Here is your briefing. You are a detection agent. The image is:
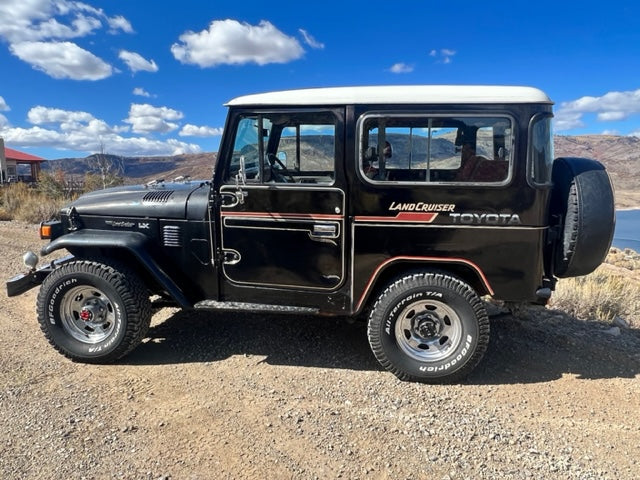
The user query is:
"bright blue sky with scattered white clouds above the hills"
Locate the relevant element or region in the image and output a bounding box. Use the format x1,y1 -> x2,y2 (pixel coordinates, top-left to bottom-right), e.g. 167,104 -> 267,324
0,0 -> 640,159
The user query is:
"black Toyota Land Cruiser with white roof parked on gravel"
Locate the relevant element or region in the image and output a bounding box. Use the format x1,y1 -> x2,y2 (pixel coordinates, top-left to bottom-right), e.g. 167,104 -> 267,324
7,86 -> 614,382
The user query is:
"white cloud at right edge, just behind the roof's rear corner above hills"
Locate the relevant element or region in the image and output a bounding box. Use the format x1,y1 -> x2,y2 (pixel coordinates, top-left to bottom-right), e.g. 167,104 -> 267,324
555,89 -> 640,130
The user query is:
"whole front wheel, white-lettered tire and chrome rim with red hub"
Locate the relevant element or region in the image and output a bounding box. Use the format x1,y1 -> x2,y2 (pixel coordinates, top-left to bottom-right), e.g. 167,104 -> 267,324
37,261 -> 151,363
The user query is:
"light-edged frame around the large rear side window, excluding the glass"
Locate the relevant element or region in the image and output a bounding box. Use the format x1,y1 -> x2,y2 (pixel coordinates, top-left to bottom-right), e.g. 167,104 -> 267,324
355,110 -> 518,187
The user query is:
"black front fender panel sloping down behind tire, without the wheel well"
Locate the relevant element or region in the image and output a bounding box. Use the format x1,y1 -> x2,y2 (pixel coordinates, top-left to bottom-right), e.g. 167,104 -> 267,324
40,229 -> 193,308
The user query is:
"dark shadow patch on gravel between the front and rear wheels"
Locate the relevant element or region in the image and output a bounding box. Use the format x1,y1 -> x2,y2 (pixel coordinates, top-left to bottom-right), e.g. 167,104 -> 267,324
123,311 -> 381,370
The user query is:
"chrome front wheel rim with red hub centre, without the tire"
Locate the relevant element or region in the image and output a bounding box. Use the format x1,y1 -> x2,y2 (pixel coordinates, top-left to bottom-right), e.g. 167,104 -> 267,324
60,285 -> 116,344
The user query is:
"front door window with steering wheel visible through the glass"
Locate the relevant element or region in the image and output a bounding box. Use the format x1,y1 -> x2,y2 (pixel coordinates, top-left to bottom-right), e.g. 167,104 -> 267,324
226,112 -> 337,184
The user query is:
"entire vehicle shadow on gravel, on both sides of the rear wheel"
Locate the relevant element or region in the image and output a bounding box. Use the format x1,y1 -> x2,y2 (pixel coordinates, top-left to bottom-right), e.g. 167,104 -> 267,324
123,311 -> 640,385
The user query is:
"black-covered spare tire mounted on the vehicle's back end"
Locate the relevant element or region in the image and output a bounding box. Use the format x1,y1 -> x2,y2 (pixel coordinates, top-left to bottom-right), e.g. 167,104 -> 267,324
551,158 -> 615,278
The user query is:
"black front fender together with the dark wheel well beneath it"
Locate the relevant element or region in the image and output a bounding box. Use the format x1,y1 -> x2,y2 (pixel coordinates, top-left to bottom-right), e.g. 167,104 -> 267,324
41,230 -> 193,308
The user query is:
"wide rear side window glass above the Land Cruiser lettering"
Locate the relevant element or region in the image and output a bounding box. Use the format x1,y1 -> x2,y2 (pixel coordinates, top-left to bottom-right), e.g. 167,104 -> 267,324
359,114 -> 513,183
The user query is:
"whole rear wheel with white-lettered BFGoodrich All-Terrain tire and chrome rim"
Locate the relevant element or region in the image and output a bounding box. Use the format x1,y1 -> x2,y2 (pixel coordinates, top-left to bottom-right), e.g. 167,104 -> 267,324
368,273 -> 489,383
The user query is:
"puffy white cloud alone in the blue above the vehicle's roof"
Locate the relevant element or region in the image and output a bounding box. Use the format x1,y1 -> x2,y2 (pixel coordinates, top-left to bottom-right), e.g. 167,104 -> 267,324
171,19 -> 304,67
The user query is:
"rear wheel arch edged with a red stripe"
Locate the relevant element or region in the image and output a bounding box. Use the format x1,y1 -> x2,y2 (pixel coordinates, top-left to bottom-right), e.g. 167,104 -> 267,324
354,257 -> 494,313
